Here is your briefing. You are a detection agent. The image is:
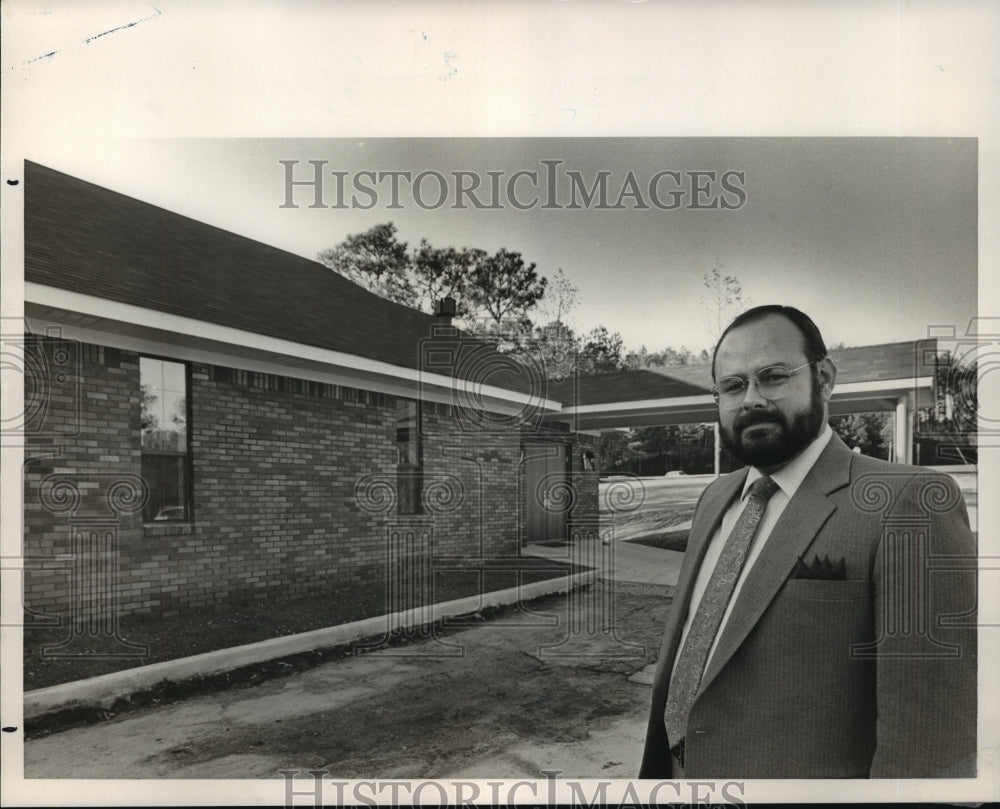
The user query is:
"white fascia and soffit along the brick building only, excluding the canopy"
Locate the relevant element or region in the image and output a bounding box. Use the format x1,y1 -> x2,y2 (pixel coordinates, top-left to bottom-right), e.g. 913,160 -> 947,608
24,281 -> 561,414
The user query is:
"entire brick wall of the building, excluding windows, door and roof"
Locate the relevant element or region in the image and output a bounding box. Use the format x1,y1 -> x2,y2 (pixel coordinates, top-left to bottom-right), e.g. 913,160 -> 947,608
24,332 -> 580,617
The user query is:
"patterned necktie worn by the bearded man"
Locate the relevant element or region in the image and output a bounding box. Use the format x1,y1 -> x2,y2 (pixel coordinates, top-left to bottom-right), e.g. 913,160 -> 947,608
663,477 -> 778,745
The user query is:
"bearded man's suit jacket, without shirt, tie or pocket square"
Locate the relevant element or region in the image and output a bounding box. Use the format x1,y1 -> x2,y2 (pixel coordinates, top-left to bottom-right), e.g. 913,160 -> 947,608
640,436 -> 976,778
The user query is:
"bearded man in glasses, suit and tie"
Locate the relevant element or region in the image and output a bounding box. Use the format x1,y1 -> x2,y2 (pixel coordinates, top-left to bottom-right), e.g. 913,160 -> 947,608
640,306 -> 976,778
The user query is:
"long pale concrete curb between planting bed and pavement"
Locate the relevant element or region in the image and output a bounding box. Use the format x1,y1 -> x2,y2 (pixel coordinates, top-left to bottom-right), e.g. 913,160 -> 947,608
24,570 -> 598,720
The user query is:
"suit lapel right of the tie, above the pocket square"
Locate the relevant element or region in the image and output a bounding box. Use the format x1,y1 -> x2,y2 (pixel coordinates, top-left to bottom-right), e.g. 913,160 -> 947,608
701,435 -> 852,688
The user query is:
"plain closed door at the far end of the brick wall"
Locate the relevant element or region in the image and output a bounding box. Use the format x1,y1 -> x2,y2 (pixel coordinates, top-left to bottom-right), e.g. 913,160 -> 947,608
524,441 -> 570,542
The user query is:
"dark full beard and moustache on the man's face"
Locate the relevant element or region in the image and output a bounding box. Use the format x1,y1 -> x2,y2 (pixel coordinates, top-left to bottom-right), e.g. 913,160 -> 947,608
719,379 -> 823,469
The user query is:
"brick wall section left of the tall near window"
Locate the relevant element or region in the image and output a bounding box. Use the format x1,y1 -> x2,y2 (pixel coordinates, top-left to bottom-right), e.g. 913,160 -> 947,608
23,336 -> 142,623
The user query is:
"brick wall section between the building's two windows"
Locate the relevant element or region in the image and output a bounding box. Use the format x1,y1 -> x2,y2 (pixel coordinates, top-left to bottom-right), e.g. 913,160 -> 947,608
182,364 -> 395,605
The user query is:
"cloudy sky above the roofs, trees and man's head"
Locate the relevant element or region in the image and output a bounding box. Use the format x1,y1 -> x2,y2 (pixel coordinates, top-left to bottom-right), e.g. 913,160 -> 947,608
26,138 -> 977,350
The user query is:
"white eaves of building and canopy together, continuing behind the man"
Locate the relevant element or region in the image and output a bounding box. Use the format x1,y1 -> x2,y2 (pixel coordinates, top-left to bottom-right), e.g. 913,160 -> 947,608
24,282 -> 934,432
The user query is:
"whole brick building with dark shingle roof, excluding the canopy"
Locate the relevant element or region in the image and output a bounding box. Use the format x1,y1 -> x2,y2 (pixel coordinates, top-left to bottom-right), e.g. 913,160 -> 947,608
24,163 -> 597,617
